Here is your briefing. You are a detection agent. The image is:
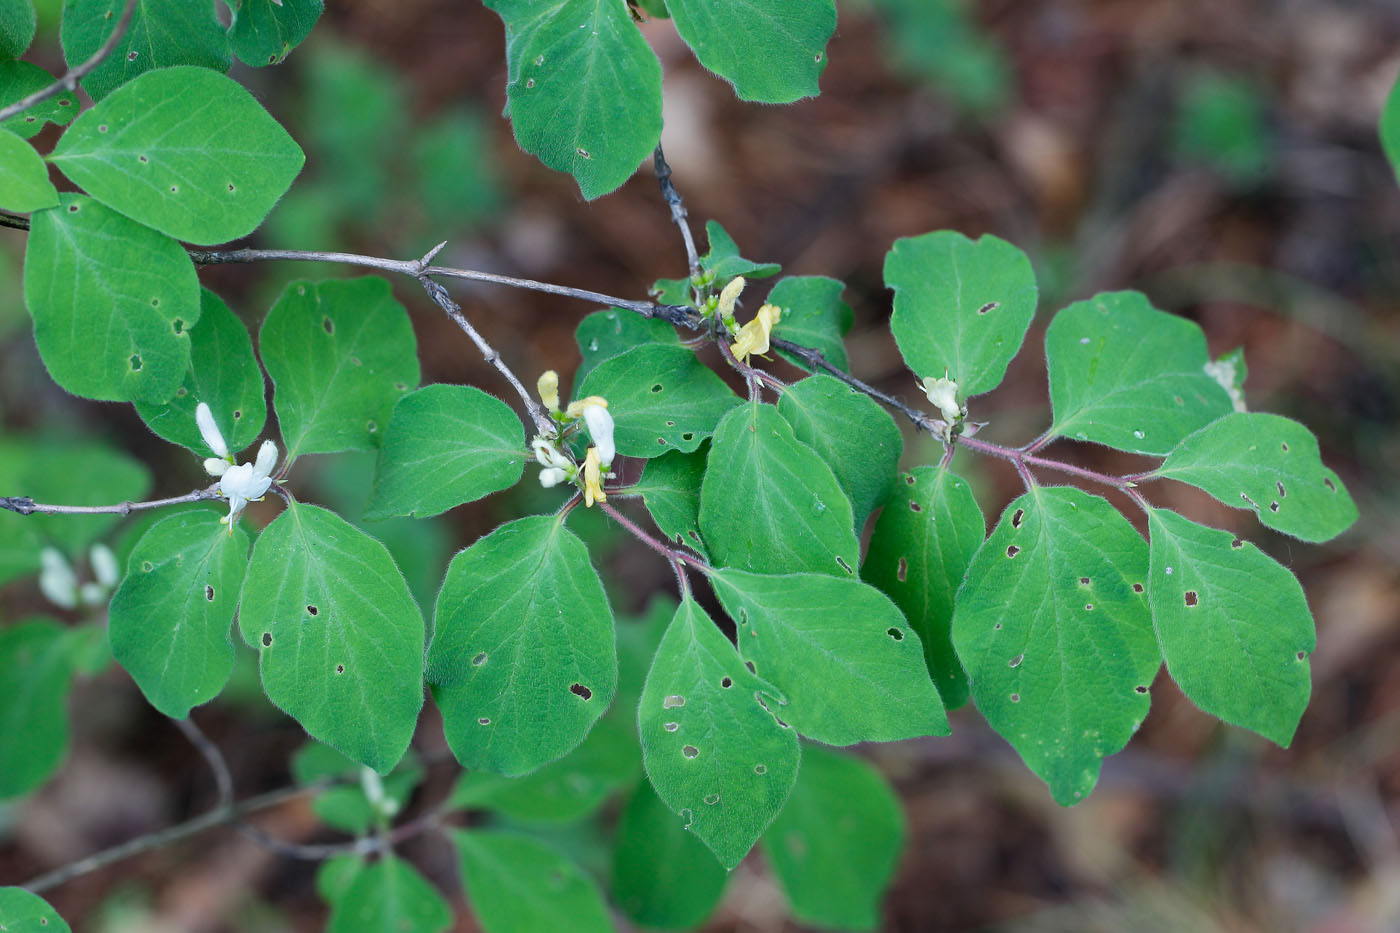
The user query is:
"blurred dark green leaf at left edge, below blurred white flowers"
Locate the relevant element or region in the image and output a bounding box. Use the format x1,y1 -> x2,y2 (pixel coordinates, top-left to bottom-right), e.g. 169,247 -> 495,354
0,619 -> 73,790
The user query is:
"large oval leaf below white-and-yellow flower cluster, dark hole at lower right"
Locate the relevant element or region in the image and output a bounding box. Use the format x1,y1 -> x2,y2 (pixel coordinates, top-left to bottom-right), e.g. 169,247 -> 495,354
427,516 -> 617,776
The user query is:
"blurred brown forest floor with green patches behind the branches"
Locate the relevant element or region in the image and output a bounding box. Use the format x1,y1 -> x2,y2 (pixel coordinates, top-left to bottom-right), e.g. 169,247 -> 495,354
0,0 -> 1400,933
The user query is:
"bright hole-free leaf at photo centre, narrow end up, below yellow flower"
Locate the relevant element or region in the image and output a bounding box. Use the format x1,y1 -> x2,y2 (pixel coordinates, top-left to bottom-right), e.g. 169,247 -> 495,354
700,403 -> 860,576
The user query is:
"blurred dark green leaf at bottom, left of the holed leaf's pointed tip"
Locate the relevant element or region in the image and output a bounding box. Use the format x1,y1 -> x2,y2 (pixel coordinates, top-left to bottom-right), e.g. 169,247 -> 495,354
612,780 -> 729,930
